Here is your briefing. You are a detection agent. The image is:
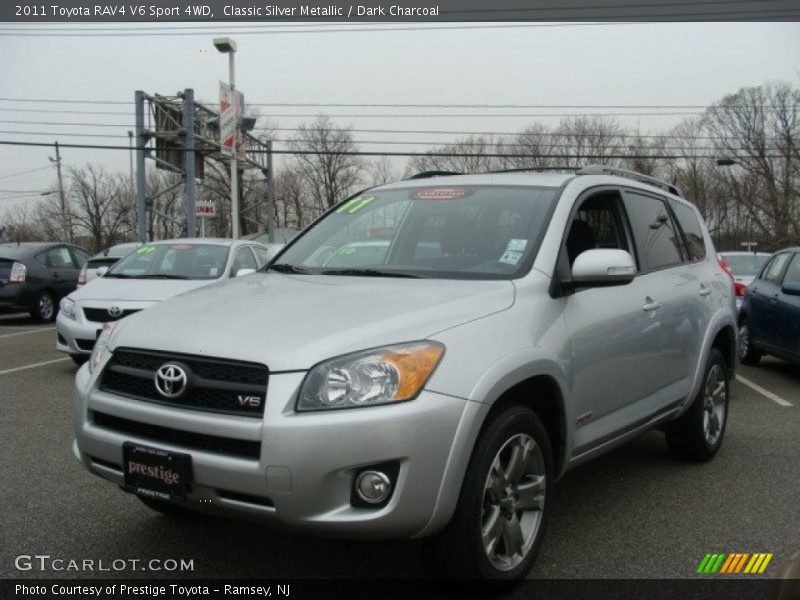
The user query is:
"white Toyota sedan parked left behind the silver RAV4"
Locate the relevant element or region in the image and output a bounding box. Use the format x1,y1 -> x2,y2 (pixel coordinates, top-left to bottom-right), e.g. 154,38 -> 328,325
56,238 -> 267,364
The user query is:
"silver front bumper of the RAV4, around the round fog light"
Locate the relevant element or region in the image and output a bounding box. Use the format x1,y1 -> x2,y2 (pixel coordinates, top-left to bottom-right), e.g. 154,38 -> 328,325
74,367 -> 470,539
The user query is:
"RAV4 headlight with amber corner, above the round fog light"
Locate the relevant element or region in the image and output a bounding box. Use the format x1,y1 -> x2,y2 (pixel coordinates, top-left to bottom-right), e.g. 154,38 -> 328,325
297,342 -> 444,411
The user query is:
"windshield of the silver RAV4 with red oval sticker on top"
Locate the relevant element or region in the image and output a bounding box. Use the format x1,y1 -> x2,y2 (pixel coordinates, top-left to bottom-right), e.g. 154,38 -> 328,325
270,186 -> 557,279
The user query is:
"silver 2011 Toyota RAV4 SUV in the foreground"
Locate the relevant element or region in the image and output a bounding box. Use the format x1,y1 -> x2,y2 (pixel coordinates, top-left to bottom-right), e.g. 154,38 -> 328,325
74,167 -> 736,579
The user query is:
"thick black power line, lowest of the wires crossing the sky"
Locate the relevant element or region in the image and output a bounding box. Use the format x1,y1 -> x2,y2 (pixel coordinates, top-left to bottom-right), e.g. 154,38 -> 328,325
0,140 -> 783,160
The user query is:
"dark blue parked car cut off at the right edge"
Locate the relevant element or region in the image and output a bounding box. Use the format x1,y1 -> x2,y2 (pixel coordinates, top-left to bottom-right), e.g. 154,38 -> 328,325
739,246 -> 800,365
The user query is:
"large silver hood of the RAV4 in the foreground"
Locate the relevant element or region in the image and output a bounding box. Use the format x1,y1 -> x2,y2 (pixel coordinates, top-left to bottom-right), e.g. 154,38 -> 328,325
109,273 -> 515,372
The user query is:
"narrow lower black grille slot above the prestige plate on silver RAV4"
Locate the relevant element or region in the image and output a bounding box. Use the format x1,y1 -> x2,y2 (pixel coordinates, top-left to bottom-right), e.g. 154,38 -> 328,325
91,411 -> 261,460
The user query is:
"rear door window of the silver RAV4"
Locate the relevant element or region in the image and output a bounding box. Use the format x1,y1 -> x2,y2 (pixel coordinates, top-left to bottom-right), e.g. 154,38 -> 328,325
625,191 -> 683,271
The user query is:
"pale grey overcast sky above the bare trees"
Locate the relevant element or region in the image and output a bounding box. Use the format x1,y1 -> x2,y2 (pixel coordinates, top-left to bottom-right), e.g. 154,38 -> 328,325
0,23 -> 800,215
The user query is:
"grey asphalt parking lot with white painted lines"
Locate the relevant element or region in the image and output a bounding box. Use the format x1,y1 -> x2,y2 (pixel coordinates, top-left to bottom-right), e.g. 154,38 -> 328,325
0,315 -> 800,578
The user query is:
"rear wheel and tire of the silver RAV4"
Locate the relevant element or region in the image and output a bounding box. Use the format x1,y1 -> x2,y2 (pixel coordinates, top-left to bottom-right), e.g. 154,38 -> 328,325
665,348 -> 729,462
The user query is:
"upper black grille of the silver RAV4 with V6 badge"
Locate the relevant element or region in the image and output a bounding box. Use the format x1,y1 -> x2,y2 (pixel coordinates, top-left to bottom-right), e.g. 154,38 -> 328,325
100,348 -> 268,417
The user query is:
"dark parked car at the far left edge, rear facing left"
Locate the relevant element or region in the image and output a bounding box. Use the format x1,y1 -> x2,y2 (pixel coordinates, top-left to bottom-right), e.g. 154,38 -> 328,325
0,242 -> 89,323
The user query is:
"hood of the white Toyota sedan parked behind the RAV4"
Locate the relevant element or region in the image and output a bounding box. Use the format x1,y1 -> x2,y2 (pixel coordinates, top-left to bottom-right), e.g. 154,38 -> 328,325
69,277 -> 217,302
